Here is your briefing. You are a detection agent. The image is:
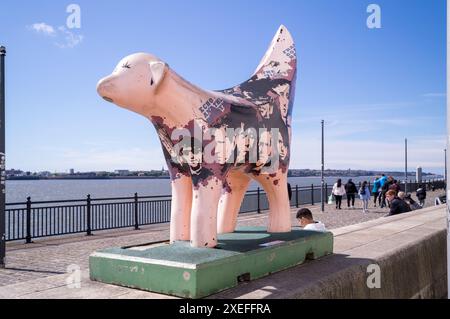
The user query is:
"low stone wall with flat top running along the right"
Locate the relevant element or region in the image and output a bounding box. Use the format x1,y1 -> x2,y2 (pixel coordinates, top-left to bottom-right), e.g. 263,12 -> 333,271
213,206 -> 447,299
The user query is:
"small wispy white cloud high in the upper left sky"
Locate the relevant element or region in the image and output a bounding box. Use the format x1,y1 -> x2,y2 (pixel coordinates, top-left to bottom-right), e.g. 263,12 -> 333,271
28,22 -> 84,49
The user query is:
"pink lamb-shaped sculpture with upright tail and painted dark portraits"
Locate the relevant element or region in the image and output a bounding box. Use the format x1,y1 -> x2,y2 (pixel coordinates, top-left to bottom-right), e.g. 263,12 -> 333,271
97,26 -> 297,247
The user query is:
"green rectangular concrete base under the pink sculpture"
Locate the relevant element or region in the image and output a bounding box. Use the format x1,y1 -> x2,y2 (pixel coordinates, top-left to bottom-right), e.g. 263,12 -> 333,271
89,227 -> 333,298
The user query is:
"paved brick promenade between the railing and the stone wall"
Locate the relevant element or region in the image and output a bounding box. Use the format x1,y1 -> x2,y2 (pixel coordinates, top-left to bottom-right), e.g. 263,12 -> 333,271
0,192 -> 442,298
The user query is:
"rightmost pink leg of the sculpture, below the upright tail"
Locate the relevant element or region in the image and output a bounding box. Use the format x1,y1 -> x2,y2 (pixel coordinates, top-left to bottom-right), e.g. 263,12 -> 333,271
254,171 -> 292,233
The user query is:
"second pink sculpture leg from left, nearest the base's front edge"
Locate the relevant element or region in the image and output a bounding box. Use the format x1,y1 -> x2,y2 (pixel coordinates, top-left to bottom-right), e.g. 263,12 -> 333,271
191,177 -> 223,248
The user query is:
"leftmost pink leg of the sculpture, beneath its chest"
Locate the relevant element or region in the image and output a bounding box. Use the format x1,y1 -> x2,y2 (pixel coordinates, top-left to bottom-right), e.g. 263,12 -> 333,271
170,176 -> 192,243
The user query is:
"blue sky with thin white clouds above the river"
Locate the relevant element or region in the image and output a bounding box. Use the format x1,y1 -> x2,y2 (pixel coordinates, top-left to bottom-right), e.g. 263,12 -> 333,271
0,0 -> 446,172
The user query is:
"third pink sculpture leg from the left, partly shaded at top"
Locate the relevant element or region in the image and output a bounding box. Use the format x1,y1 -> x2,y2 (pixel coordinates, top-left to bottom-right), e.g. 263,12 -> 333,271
217,171 -> 251,234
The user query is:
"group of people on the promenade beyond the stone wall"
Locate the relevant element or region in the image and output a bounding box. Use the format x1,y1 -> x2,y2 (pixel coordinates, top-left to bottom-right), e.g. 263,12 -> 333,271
332,174 -> 427,215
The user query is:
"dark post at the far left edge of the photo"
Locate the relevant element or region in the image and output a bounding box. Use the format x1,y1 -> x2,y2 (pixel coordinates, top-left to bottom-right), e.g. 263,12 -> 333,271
0,46 -> 6,268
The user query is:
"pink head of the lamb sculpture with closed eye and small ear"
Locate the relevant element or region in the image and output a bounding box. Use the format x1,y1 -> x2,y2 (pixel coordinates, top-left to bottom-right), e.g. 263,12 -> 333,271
97,53 -> 167,115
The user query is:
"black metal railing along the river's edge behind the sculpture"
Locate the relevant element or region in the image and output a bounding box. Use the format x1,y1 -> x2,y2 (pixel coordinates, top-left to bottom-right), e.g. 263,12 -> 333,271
5,180 -> 445,243
